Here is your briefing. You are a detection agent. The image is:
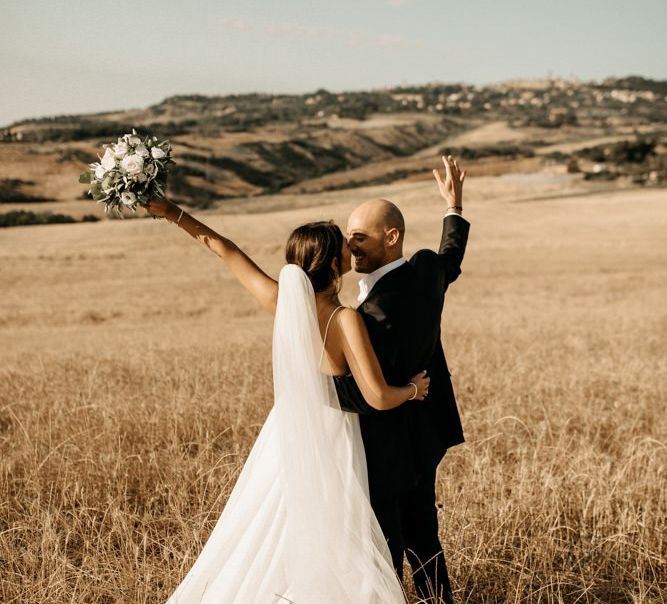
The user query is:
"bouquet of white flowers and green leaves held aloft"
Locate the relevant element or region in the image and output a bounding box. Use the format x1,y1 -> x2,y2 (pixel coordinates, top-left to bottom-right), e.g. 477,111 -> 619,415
79,129 -> 174,218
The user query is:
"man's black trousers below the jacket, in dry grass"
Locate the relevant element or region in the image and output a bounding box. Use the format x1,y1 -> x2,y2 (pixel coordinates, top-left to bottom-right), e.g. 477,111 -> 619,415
371,460 -> 453,604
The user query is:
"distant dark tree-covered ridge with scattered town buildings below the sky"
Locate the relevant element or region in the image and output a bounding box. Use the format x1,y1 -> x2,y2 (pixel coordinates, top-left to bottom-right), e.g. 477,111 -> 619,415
0,77 -> 667,142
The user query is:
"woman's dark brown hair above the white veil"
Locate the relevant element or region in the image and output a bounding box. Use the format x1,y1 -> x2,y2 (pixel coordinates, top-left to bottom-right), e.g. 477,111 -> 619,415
285,220 -> 344,293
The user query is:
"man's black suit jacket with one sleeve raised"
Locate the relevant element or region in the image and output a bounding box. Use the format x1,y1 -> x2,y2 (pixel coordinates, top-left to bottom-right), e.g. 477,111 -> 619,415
334,215 -> 470,498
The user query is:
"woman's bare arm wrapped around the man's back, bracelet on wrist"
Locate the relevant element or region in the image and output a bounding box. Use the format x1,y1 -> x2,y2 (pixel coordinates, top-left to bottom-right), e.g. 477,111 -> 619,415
337,308 -> 431,411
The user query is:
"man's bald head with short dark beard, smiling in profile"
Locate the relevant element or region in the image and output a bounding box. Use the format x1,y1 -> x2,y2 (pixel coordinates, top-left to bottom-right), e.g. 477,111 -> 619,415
347,199 -> 405,273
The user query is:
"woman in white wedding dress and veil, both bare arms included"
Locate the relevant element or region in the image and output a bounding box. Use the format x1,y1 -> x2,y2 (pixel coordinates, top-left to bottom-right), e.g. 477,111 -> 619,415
145,199 -> 429,604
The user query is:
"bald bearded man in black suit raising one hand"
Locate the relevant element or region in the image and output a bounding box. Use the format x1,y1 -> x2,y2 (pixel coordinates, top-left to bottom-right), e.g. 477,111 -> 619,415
335,156 -> 470,603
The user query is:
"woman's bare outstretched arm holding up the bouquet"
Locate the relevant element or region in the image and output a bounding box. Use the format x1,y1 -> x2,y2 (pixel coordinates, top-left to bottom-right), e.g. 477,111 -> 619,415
144,199 -> 278,314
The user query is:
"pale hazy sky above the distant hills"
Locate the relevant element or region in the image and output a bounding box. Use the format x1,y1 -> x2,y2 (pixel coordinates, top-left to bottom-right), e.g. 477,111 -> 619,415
0,0 -> 667,126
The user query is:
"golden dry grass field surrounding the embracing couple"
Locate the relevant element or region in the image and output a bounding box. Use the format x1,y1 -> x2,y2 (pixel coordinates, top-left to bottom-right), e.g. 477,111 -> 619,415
0,178 -> 667,604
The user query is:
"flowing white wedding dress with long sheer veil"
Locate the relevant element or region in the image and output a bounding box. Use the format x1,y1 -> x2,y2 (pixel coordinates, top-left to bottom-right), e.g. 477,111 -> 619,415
167,264 -> 405,604
